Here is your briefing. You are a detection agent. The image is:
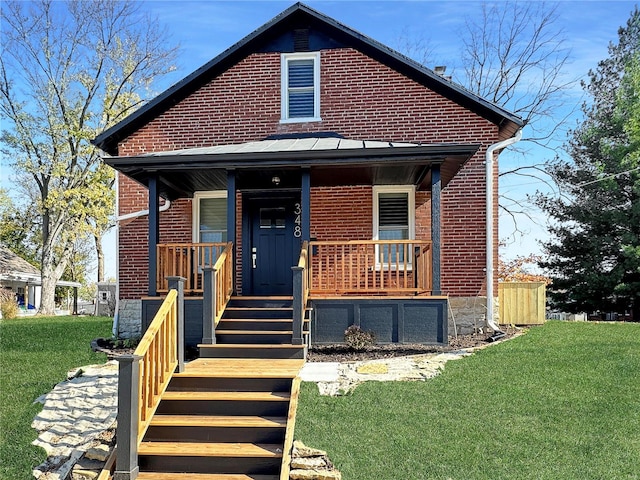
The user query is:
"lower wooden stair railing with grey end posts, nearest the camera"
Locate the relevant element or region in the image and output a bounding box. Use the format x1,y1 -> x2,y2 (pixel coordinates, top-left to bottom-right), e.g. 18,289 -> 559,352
113,277 -> 185,480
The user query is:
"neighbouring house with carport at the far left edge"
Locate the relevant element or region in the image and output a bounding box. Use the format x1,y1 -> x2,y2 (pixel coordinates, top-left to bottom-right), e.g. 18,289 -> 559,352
0,245 -> 80,313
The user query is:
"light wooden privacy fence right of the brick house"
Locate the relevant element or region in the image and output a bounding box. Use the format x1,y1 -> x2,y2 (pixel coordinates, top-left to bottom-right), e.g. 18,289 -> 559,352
498,282 -> 547,325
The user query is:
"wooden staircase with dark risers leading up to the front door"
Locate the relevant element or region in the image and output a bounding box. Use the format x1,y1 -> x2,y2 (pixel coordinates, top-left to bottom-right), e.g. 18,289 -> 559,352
132,297 -> 305,480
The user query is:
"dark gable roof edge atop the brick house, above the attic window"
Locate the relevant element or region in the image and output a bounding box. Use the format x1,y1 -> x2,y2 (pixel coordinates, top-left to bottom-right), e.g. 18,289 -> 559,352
92,2 -> 523,155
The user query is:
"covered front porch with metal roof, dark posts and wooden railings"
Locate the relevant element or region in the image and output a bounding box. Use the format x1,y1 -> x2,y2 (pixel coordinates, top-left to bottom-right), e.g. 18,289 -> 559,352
105,136 -> 479,343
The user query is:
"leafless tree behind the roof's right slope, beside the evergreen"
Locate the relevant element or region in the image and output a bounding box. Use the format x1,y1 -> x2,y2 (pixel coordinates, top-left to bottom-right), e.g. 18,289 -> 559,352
462,1 -> 576,146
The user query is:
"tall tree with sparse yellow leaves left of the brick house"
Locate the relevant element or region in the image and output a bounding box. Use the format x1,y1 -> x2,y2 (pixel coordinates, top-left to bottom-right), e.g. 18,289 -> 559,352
0,0 -> 175,314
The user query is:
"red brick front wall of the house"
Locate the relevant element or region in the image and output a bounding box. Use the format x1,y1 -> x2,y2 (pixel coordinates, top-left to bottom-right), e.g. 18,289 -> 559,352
118,49 -> 498,298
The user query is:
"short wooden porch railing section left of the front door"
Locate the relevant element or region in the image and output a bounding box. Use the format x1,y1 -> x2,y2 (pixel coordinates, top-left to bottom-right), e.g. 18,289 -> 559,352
156,243 -> 227,295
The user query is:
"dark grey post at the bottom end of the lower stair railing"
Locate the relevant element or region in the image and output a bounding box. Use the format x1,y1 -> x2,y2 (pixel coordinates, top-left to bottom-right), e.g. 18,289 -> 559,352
113,355 -> 142,480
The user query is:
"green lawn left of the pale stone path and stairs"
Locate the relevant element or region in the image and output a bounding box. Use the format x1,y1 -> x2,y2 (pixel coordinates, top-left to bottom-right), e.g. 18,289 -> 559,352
0,317 -> 111,480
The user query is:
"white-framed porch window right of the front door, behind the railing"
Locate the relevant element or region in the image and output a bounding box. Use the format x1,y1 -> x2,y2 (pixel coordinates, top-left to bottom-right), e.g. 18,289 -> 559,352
373,186 -> 415,267
